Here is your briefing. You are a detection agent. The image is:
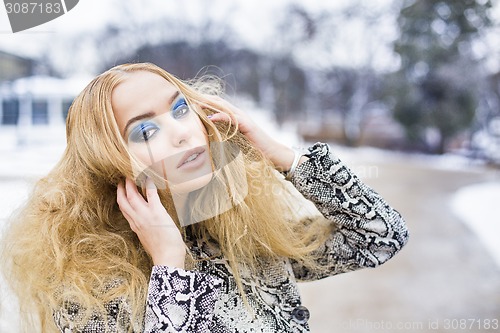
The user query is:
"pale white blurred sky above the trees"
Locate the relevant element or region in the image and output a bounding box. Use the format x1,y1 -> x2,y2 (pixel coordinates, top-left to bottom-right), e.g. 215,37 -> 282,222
0,0 -> 500,74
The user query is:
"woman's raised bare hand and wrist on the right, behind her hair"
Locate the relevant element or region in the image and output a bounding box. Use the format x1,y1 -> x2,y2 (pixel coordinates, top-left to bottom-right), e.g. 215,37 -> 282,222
201,96 -> 306,171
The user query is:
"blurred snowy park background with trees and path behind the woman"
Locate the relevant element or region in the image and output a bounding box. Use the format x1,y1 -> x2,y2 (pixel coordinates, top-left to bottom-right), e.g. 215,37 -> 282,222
0,0 -> 500,333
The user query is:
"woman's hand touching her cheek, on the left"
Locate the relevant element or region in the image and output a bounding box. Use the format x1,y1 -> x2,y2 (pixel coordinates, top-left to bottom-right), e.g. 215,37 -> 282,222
116,178 -> 186,268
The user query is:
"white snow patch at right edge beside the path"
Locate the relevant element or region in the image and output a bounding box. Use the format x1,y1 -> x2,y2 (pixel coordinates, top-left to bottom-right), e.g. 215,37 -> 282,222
450,182 -> 500,266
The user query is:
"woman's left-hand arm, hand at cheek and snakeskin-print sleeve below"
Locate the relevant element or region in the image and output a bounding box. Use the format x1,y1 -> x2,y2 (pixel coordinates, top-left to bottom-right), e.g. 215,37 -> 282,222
117,179 -> 222,332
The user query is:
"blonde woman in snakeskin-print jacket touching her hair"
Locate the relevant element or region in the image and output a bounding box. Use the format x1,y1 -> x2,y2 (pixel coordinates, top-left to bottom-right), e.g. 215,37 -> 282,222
3,64 -> 408,332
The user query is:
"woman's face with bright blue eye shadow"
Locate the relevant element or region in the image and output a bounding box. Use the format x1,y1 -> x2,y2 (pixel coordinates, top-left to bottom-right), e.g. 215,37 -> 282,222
111,71 -> 212,194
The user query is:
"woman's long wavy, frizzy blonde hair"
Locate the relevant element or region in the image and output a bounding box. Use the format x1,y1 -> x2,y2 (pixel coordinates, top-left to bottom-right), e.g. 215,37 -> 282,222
1,63 -> 325,332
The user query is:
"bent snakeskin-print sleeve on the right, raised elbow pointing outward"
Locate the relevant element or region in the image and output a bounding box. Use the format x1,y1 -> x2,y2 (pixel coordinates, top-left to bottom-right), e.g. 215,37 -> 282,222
292,143 -> 408,281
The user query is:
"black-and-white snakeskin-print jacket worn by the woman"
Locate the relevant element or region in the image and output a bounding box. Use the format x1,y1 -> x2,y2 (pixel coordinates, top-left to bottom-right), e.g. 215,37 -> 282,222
54,143 -> 408,333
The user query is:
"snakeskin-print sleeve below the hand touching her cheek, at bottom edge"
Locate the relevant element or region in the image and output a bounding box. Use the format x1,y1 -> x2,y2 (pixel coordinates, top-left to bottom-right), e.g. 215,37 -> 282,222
144,266 -> 222,333
